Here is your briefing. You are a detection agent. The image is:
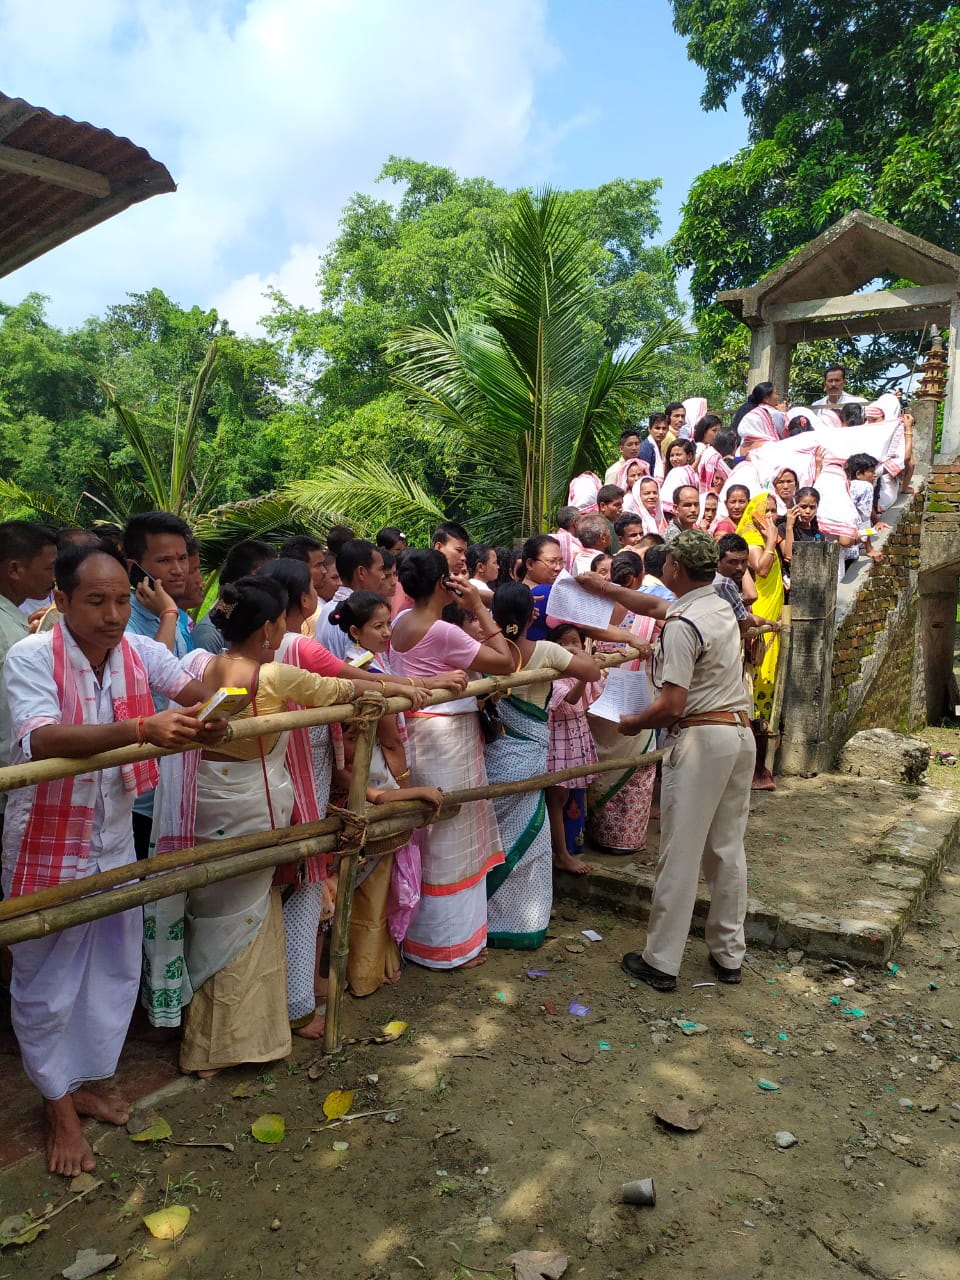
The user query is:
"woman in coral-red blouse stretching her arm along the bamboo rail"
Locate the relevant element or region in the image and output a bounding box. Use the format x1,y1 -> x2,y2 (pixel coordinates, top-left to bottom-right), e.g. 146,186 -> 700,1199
260,558 -> 466,1039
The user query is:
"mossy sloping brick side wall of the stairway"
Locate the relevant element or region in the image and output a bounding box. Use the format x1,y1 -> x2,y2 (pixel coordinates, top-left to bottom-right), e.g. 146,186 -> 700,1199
831,486 -> 926,750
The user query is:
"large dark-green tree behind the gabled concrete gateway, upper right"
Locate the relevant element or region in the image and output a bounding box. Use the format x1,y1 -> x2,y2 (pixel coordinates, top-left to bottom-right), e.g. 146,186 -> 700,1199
672,0 -> 960,378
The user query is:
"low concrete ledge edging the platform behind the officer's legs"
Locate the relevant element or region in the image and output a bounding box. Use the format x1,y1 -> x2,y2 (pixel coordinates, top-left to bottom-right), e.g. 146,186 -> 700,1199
556,777 -> 960,966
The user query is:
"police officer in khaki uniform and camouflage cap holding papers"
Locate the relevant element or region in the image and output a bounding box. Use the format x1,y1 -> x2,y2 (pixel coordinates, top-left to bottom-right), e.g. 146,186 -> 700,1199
593,530 -> 756,991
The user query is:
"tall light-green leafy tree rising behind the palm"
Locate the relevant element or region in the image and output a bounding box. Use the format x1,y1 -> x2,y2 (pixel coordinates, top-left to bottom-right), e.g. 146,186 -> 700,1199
265,156 -> 681,413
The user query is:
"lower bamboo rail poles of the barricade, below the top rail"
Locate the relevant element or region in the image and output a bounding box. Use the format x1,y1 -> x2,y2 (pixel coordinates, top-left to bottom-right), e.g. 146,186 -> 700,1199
0,751 -> 664,945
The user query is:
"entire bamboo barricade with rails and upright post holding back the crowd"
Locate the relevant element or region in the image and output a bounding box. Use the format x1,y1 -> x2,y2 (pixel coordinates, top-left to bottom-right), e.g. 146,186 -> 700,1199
0,648 -> 663,1052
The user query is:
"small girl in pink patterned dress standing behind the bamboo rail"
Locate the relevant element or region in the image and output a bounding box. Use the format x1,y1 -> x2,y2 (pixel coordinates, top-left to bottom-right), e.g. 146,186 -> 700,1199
547,622 -> 596,876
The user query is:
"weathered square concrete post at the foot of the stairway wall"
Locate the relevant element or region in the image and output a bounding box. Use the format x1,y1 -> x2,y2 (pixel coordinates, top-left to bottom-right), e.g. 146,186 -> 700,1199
780,543 -> 840,778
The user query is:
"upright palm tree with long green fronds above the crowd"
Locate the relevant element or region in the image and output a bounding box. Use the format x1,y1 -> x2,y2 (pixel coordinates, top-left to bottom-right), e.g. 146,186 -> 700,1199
376,189 -> 685,536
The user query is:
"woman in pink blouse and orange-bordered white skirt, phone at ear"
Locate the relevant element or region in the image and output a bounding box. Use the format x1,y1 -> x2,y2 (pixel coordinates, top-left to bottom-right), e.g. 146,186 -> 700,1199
389,550 -> 513,969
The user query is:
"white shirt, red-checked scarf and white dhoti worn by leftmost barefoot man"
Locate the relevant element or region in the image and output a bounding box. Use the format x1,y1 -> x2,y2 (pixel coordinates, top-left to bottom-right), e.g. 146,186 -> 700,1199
0,622 -> 189,1100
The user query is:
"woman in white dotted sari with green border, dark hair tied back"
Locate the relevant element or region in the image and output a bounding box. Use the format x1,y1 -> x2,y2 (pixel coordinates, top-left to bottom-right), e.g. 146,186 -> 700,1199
484,582 -> 602,950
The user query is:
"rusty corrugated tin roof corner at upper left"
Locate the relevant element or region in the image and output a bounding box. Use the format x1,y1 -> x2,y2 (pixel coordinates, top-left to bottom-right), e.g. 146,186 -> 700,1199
0,93 -> 177,276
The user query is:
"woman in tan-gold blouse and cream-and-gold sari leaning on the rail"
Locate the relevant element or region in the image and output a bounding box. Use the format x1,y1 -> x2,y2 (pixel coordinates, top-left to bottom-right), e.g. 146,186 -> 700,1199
168,576 -> 357,1076
